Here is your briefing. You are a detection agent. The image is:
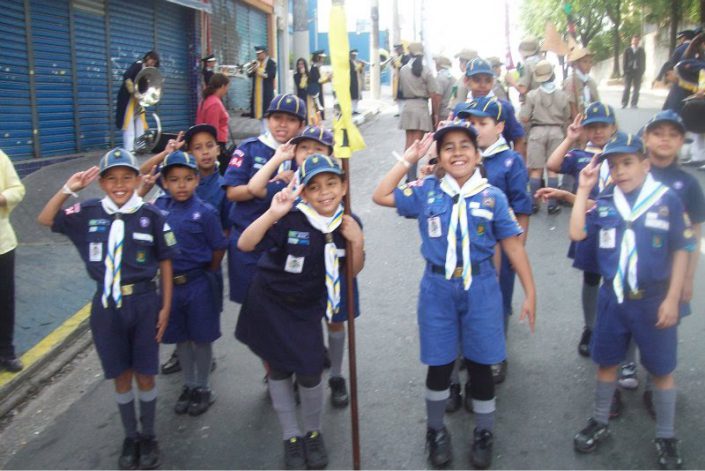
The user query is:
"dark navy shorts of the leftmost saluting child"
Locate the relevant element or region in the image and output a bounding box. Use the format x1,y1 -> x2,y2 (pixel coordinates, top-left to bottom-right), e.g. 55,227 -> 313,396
90,290 -> 161,379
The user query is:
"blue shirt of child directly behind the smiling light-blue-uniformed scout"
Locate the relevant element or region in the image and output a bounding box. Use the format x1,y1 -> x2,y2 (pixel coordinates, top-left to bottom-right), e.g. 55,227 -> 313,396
482,149 -> 532,214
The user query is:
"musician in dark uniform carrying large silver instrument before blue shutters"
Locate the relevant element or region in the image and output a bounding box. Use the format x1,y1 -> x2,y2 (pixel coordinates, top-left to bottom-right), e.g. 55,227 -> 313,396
115,51 -> 159,152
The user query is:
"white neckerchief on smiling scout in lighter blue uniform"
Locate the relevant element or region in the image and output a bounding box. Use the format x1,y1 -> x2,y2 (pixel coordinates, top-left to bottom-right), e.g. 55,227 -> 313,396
441,169 -> 489,290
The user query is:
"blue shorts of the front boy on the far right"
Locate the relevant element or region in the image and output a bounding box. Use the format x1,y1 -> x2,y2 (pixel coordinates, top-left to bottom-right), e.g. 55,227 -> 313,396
591,280 -> 678,376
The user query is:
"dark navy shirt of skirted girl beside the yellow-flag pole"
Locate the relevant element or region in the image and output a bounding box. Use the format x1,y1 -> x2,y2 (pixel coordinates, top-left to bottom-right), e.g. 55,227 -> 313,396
256,208 -> 362,322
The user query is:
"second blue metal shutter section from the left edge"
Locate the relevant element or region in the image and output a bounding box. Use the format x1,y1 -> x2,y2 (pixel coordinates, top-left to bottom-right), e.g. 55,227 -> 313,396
30,0 -> 76,156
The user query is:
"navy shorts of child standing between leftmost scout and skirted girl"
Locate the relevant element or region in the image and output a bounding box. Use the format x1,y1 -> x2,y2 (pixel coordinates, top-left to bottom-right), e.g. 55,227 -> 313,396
163,270 -> 220,343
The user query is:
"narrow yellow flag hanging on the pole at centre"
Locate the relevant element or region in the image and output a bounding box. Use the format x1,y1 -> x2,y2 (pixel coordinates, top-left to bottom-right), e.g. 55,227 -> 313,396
328,4 -> 365,159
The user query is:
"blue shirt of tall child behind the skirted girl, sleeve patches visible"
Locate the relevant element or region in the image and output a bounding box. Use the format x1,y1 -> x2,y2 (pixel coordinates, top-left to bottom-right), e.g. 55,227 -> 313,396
223,138 -> 275,232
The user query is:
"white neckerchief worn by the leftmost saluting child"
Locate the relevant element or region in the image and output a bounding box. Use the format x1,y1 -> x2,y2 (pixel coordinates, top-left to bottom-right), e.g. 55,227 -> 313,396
100,192 -> 144,308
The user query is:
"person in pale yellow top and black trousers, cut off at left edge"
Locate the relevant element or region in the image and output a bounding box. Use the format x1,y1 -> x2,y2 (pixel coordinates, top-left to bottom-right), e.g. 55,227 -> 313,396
0,150 -> 25,373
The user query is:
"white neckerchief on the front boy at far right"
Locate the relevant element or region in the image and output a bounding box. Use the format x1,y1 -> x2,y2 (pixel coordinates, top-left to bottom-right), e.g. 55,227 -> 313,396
612,173 -> 668,304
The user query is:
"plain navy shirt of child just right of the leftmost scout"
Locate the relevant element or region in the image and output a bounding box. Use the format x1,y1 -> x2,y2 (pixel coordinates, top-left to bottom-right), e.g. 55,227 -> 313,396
154,195 -> 228,274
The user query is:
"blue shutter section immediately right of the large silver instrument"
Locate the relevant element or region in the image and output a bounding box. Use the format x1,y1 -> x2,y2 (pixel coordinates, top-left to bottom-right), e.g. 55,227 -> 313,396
156,2 -> 198,132
